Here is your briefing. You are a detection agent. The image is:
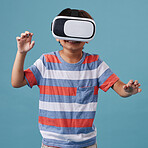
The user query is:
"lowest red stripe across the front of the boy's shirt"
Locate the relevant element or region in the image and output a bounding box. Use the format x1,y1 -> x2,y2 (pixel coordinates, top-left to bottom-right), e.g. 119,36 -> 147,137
39,116 -> 94,127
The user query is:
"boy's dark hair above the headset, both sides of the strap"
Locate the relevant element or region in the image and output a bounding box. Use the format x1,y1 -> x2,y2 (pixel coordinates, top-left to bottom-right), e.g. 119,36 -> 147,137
58,8 -> 93,19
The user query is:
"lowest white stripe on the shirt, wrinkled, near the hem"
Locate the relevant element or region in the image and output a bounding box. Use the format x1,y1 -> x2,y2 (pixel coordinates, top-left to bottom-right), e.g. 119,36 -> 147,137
40,130 -> 96,142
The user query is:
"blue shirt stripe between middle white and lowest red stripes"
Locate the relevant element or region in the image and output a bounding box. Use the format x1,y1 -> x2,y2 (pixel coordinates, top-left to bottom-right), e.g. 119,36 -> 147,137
39,109 -> 95,119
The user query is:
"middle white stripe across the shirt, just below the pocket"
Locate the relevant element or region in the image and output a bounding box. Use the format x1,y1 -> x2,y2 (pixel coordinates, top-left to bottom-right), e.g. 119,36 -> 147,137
39,101 -> 97,112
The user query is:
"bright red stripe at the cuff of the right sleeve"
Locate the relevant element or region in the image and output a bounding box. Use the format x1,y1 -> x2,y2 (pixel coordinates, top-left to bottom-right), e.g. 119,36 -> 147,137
100,73 -> 119,92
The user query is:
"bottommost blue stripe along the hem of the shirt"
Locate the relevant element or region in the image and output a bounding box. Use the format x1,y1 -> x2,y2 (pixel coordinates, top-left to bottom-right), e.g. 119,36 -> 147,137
42,137 -> 96,148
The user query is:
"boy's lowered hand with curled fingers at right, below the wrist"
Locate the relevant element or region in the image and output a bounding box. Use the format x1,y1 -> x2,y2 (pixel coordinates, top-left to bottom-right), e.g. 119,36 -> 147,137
123,80 -> 142,95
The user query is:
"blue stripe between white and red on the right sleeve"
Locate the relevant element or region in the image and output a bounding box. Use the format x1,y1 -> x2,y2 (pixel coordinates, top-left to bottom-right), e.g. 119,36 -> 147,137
98,68 -> 113,87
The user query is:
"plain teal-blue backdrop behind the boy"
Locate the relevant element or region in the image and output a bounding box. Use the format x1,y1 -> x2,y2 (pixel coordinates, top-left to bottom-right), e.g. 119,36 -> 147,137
0,0 -> 148,148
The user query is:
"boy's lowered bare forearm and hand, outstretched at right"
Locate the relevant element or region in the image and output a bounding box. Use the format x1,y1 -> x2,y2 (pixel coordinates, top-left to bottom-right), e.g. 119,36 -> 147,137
112,80 -> 142,97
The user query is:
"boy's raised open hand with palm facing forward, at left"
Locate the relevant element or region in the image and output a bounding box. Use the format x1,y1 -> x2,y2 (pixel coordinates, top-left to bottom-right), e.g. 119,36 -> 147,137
16,31 -> 35,53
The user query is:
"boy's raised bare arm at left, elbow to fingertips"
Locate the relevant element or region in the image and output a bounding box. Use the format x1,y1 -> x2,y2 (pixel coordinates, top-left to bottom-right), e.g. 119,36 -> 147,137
11,31 -> 35,88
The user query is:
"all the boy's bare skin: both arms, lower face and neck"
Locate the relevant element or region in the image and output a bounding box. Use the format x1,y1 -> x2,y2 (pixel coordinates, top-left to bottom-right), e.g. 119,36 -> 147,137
11,31 -> 142,97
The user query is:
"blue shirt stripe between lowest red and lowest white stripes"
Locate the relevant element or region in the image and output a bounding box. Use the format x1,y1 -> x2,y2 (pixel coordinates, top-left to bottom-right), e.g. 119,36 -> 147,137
39,123 -> 94,134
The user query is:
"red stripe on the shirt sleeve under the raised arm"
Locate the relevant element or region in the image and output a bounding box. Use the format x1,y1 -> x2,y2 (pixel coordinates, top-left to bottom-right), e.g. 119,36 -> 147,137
24,68 -> 37,87
